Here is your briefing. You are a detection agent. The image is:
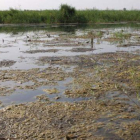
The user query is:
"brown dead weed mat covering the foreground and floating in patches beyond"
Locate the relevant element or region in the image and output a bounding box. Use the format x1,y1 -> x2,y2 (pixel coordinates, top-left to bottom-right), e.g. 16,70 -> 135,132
0,27 -> 140,140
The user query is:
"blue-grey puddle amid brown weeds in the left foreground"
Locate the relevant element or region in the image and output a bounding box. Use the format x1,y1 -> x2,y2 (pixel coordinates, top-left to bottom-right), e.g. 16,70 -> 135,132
0,78 -> 90,106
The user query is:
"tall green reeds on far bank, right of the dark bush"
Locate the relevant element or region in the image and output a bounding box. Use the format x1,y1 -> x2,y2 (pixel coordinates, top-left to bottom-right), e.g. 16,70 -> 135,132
78,10 -> 140,23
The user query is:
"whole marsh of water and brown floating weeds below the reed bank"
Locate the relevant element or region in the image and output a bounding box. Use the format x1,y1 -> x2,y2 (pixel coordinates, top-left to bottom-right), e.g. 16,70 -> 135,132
0,24 -> 140,140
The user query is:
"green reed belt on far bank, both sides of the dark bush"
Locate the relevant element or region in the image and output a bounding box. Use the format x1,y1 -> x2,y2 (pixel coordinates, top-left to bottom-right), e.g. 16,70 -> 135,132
0,9 -> 140,24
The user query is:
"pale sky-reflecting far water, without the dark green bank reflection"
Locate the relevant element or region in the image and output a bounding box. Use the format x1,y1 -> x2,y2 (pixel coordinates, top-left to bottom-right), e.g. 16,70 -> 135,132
0,26 -> 139,69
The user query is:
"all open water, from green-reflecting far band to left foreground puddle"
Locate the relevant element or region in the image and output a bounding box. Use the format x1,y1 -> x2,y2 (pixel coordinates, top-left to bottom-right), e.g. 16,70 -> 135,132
0,24 -> 140,105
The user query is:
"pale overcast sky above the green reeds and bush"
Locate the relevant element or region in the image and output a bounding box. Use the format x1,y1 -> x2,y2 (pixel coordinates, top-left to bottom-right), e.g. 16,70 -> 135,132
0,0 -> 140,10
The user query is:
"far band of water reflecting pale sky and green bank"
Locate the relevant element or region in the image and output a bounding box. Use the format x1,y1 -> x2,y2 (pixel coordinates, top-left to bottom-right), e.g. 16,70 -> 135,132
0,24 -> 140,69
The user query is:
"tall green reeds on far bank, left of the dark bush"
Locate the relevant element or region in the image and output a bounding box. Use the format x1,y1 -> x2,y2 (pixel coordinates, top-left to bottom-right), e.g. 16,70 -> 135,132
0,9 -> 58,23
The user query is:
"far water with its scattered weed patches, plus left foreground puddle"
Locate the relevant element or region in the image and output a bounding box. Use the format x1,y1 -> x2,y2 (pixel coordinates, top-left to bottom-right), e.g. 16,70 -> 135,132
0,25 -> 140,106
